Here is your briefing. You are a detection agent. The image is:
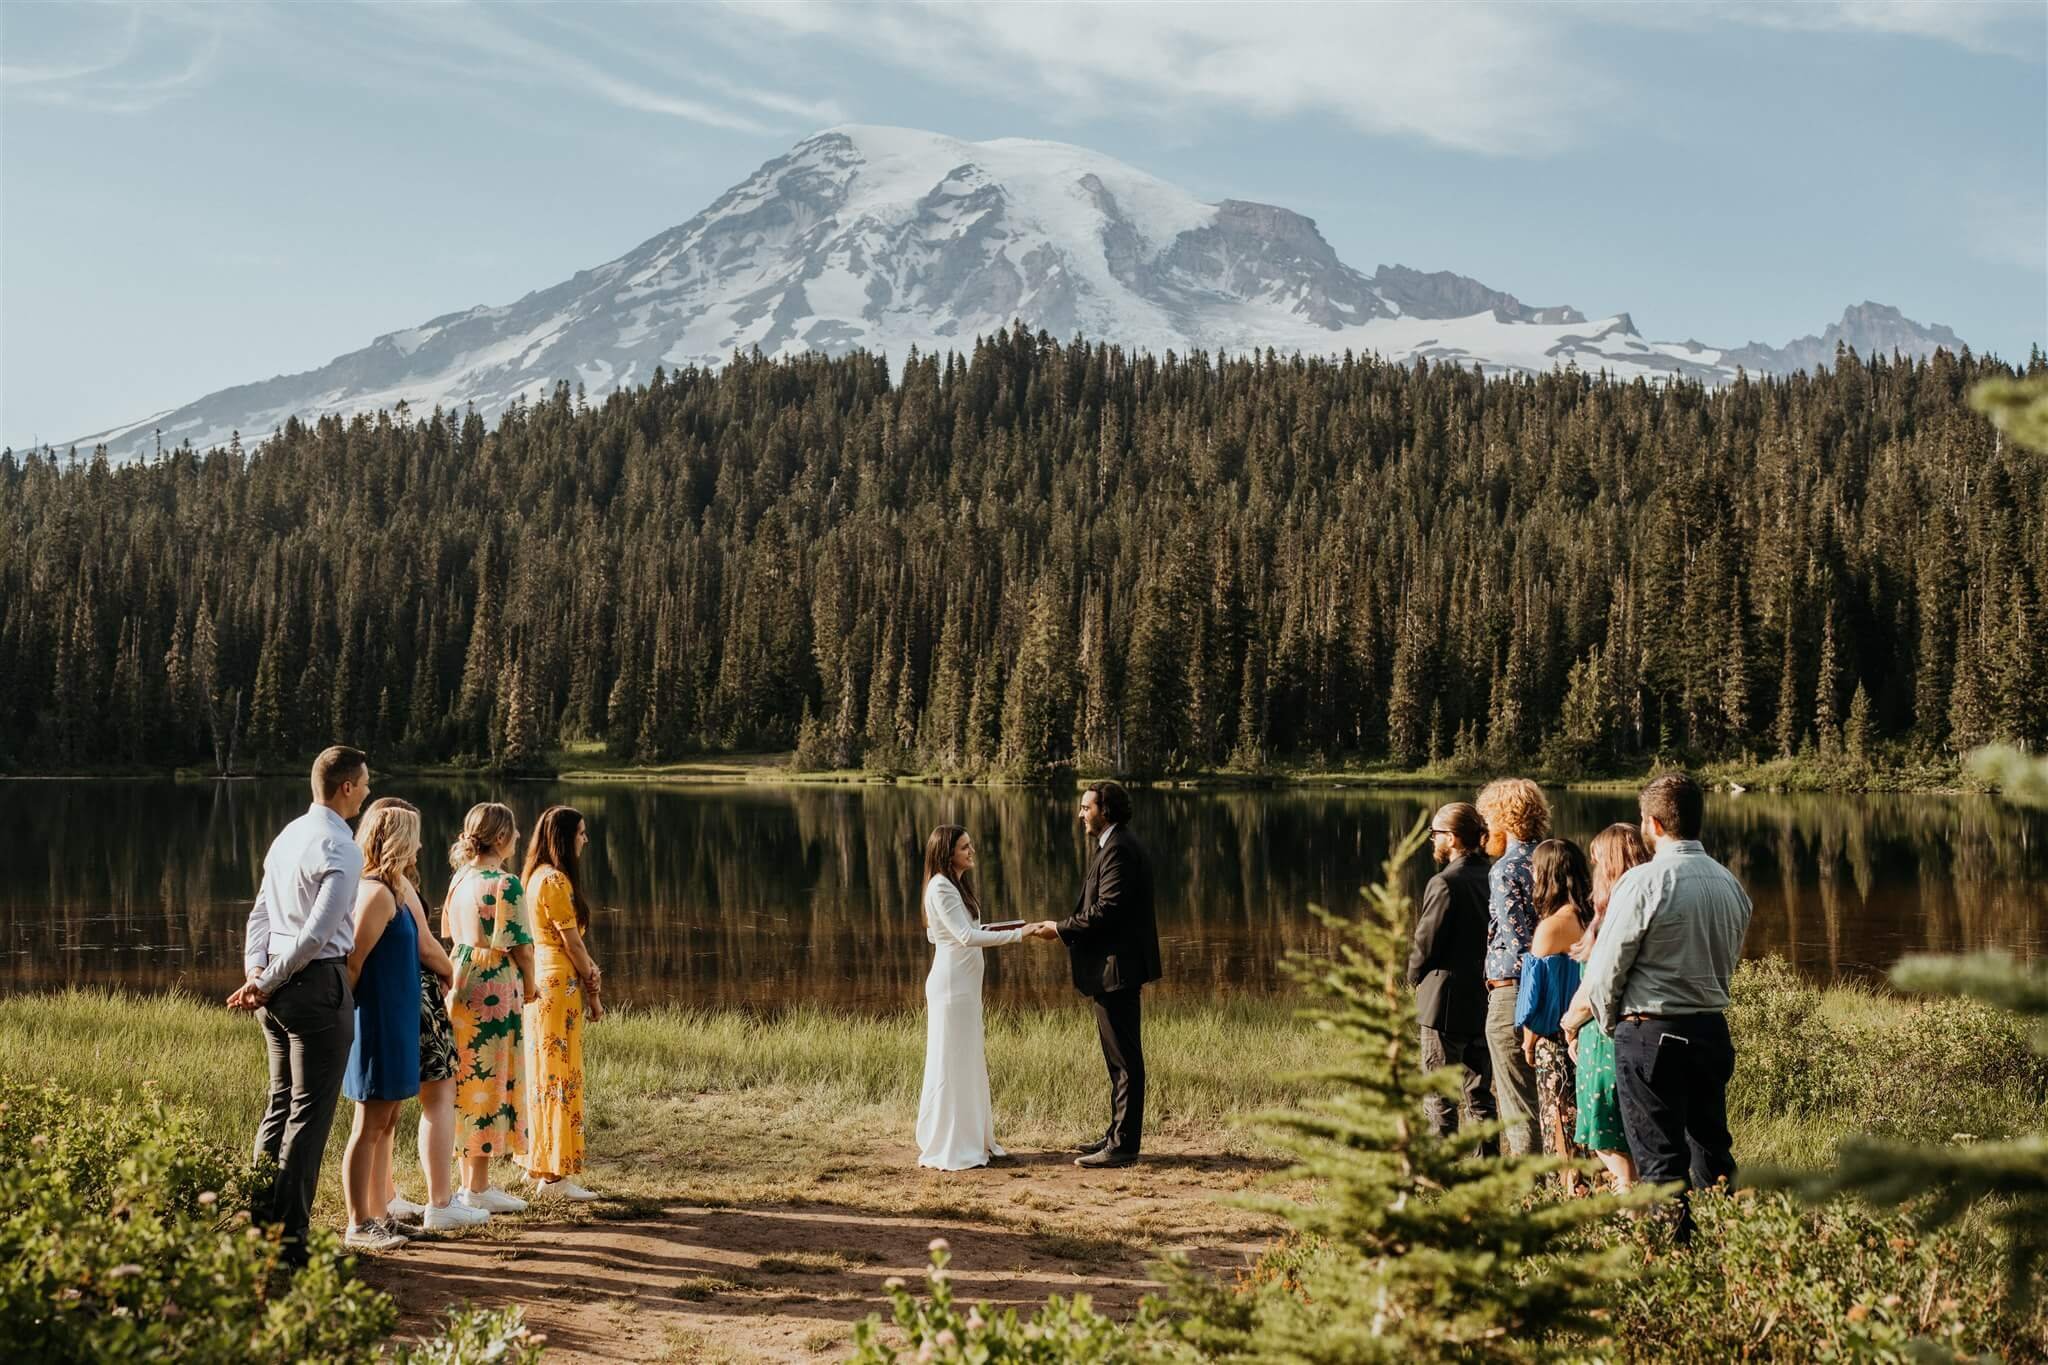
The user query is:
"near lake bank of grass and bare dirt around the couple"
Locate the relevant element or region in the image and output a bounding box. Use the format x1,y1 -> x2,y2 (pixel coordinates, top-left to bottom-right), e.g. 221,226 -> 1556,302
0,964 -> 2048,1361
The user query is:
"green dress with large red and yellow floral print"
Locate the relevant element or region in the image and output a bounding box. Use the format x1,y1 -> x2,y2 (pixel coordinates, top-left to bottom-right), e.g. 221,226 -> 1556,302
449,868 -> 532,1156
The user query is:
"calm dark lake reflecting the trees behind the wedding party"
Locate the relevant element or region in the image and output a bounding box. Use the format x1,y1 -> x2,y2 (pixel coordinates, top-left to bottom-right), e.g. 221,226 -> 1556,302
0,778 -> 2048,1009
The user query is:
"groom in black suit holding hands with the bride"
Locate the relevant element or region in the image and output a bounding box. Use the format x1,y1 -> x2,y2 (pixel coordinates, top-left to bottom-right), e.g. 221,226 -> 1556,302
1059,782 -> 1161,1169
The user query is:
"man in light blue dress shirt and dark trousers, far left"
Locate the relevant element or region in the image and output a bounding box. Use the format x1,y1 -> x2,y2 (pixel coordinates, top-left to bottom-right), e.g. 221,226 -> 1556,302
227,745 -> 371,1265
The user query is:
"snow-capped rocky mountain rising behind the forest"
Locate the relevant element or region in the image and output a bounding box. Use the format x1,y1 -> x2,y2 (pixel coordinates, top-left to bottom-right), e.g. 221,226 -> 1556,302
76,127 -> 1960,454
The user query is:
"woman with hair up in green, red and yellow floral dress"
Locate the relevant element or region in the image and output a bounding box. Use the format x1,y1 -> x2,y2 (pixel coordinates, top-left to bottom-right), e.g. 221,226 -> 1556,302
440,800 -> 532,1214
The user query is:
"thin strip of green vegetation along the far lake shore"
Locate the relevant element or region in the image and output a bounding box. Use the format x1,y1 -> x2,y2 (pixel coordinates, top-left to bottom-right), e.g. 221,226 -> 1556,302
0,743 -> 1999,796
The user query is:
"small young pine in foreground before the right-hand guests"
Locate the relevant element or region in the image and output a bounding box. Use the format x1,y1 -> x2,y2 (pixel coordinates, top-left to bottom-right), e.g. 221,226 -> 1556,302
1169,821 -> 1659,1365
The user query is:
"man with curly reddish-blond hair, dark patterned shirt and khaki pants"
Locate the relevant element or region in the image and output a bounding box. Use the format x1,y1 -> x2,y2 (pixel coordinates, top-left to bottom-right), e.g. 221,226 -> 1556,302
1475,778 -> 1550,1154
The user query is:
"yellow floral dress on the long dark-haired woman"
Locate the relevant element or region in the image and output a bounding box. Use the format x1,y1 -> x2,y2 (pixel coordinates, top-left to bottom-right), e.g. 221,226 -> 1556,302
526,868 -> 584,1177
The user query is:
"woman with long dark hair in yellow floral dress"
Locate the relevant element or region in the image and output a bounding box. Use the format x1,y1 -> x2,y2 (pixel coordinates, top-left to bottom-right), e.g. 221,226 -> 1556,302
524,806 -> 604,1199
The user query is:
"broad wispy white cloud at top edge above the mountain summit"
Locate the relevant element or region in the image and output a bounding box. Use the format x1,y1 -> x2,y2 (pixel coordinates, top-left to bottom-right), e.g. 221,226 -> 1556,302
731,0 -> 1614,153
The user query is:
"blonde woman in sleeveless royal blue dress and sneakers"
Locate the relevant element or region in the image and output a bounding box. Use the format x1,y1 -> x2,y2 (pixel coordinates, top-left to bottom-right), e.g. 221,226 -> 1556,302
342,806 -> 420,1250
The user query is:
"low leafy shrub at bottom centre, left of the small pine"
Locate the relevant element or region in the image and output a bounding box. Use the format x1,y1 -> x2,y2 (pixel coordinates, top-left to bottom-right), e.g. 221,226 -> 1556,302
852,1240 -> 1159,1365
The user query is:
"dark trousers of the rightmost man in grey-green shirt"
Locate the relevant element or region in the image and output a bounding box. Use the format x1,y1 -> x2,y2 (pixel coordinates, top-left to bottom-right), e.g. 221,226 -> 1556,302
1614,1015 -> 1735,1246
